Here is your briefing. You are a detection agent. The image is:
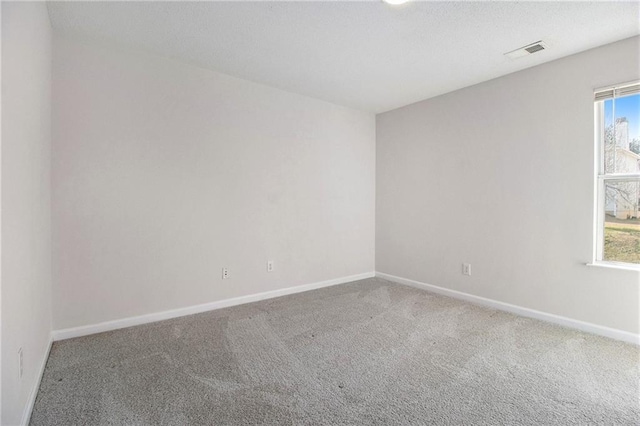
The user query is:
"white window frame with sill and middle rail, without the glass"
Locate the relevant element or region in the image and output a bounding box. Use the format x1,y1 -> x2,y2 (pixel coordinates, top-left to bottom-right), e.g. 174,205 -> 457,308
589,80 -> 640,271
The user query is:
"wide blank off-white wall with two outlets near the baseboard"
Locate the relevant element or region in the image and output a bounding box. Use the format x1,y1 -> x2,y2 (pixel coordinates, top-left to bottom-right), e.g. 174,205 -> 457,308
52,37 -> 375,329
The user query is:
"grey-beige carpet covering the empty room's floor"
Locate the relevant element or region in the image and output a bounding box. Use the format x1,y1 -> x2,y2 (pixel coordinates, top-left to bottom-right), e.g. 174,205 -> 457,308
31,278 -> 640,426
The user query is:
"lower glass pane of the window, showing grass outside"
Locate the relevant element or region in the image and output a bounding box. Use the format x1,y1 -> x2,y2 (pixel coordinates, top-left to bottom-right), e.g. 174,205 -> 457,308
603,179 -> 640,264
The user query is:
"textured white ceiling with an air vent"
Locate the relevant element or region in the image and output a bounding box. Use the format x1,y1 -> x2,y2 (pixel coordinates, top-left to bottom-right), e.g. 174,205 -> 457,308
49,1 -> 640,112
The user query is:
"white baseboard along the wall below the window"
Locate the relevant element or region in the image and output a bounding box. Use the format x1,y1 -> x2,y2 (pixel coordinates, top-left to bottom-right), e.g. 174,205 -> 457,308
376,272 -> 640,345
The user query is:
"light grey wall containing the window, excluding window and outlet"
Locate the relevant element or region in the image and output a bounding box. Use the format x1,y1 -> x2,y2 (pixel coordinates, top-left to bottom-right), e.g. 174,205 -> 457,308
376,37 -> 640,333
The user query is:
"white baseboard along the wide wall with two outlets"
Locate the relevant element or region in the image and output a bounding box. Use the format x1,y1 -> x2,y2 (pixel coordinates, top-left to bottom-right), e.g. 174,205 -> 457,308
53,272 -> 375,341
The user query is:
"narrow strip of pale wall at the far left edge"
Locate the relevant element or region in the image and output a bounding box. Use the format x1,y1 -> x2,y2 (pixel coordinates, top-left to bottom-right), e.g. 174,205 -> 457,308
1,2 -> 51,425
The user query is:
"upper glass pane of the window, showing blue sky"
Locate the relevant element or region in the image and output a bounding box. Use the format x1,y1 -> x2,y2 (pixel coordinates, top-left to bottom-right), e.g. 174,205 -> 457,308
604,94 -> 640,174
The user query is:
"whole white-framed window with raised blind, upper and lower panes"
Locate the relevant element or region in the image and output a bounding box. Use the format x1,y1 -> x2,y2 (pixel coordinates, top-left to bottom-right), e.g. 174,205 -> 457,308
595,83 -> 640,268
